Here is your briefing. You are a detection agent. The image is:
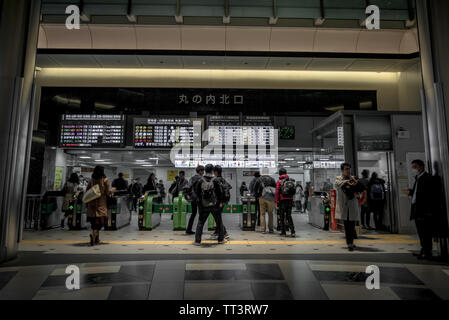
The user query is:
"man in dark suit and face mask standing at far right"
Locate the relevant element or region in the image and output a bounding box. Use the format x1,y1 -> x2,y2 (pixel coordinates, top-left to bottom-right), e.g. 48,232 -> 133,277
409,160 -> 435,259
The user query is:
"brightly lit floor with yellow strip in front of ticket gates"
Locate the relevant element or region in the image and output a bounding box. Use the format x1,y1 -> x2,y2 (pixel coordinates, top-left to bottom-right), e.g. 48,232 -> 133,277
20,214 -> 419,255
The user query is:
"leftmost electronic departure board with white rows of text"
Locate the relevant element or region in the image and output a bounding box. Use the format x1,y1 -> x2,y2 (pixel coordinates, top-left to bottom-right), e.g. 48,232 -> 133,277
59,114 -> 125,148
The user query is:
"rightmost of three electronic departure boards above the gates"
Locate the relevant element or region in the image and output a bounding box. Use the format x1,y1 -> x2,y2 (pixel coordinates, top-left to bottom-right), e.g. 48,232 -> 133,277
208,116 -> 275,146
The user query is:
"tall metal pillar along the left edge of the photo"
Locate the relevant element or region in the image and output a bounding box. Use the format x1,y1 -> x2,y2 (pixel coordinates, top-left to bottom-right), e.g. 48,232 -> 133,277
0,0 -> 41,262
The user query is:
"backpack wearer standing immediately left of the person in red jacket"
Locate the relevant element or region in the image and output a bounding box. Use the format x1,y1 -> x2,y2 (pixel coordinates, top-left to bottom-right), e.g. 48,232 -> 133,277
254,175 -> 276,233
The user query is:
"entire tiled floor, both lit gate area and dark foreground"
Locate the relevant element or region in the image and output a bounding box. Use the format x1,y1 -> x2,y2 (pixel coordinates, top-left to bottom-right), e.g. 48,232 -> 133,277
0,215 -> 449,300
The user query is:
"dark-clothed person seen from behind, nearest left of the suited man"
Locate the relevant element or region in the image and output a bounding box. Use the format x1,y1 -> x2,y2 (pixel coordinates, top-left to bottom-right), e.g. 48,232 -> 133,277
368,172 -> 385,230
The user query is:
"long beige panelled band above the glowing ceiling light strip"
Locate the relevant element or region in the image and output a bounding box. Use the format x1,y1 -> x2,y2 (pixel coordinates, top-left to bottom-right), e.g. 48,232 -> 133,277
38,24 -> 419,54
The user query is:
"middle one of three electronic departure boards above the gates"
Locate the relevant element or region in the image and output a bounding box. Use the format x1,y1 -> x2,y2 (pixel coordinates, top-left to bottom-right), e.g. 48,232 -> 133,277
134,118 -> 202,148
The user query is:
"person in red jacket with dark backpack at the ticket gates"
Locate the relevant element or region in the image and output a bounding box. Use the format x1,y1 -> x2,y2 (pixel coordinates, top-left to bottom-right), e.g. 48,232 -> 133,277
275,168 -> 296,238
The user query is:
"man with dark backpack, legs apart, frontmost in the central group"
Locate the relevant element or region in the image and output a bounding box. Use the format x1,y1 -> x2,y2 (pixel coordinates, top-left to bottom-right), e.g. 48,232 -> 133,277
193,164 -> 225,246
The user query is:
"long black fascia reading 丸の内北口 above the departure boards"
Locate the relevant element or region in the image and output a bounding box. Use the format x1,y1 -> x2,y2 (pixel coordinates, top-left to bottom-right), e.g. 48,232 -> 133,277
38,87 -> 377,145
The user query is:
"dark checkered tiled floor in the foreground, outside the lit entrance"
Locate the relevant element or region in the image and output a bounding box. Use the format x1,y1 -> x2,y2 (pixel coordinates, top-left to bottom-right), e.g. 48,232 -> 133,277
0,260 -> 449,300
